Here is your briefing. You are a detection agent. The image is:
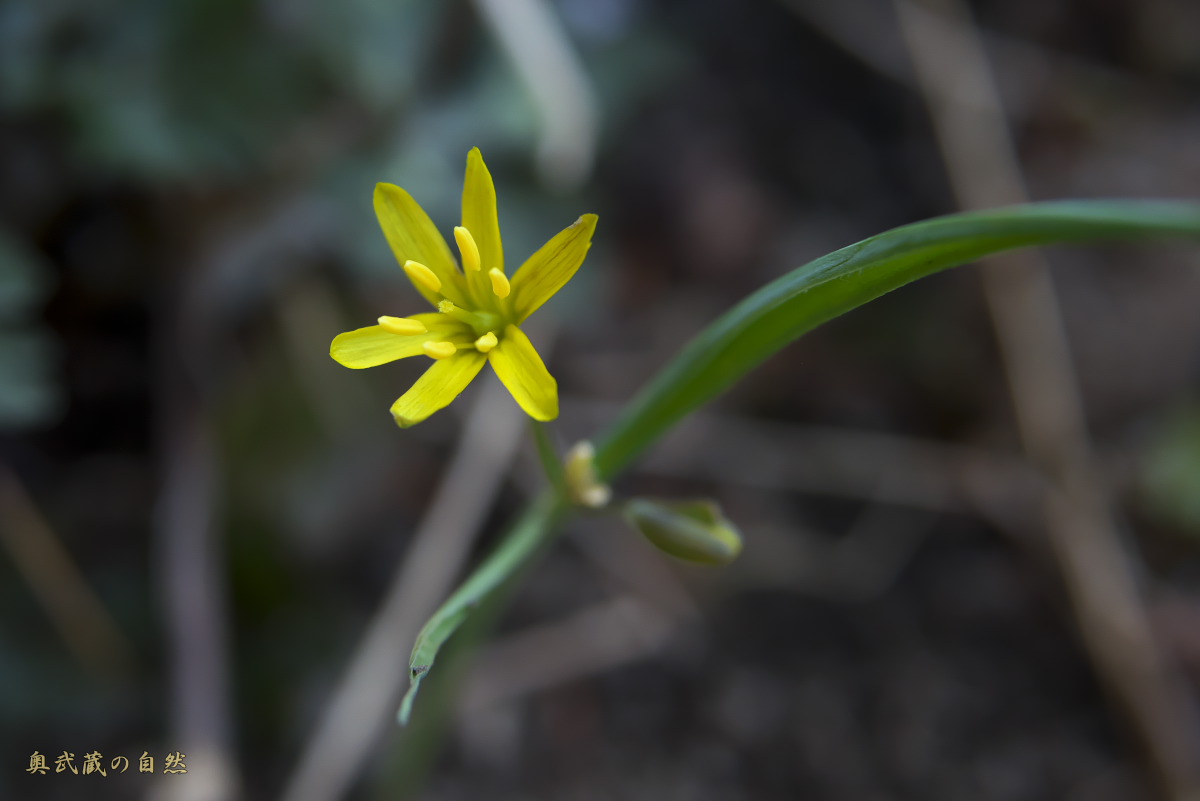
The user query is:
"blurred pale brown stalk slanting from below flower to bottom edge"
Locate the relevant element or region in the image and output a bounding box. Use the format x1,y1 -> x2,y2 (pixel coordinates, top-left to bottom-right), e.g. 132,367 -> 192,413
283,352 -> 548,801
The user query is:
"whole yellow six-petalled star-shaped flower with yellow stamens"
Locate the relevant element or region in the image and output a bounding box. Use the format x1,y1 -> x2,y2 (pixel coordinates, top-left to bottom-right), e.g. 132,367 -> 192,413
329,147 -> 596,428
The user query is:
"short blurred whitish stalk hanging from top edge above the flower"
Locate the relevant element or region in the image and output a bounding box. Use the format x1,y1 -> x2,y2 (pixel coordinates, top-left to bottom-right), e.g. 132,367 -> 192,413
475,0 -> 599,191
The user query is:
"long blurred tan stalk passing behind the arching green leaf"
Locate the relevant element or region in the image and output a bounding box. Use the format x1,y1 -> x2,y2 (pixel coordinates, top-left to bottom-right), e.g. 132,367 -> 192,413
894,0 -> 1200,801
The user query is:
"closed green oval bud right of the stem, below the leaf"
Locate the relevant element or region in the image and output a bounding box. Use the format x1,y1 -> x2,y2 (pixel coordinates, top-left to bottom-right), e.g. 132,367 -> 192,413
624,498 -> 742,565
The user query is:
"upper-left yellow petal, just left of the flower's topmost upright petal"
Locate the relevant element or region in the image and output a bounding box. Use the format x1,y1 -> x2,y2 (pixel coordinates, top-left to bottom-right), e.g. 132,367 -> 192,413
374,183 -> 463,306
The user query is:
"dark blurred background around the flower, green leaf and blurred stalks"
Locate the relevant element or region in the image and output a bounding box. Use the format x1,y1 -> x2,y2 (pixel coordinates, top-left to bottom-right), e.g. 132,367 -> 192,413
7,0 -> 1200,801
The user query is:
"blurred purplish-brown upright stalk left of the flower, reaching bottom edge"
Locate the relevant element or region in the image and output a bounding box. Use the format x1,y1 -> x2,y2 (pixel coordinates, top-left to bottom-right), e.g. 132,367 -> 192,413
151,194 -> 320,801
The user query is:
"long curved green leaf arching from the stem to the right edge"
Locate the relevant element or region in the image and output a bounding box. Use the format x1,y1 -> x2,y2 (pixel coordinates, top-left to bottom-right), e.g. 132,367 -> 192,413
596,200 -> 1200,480
